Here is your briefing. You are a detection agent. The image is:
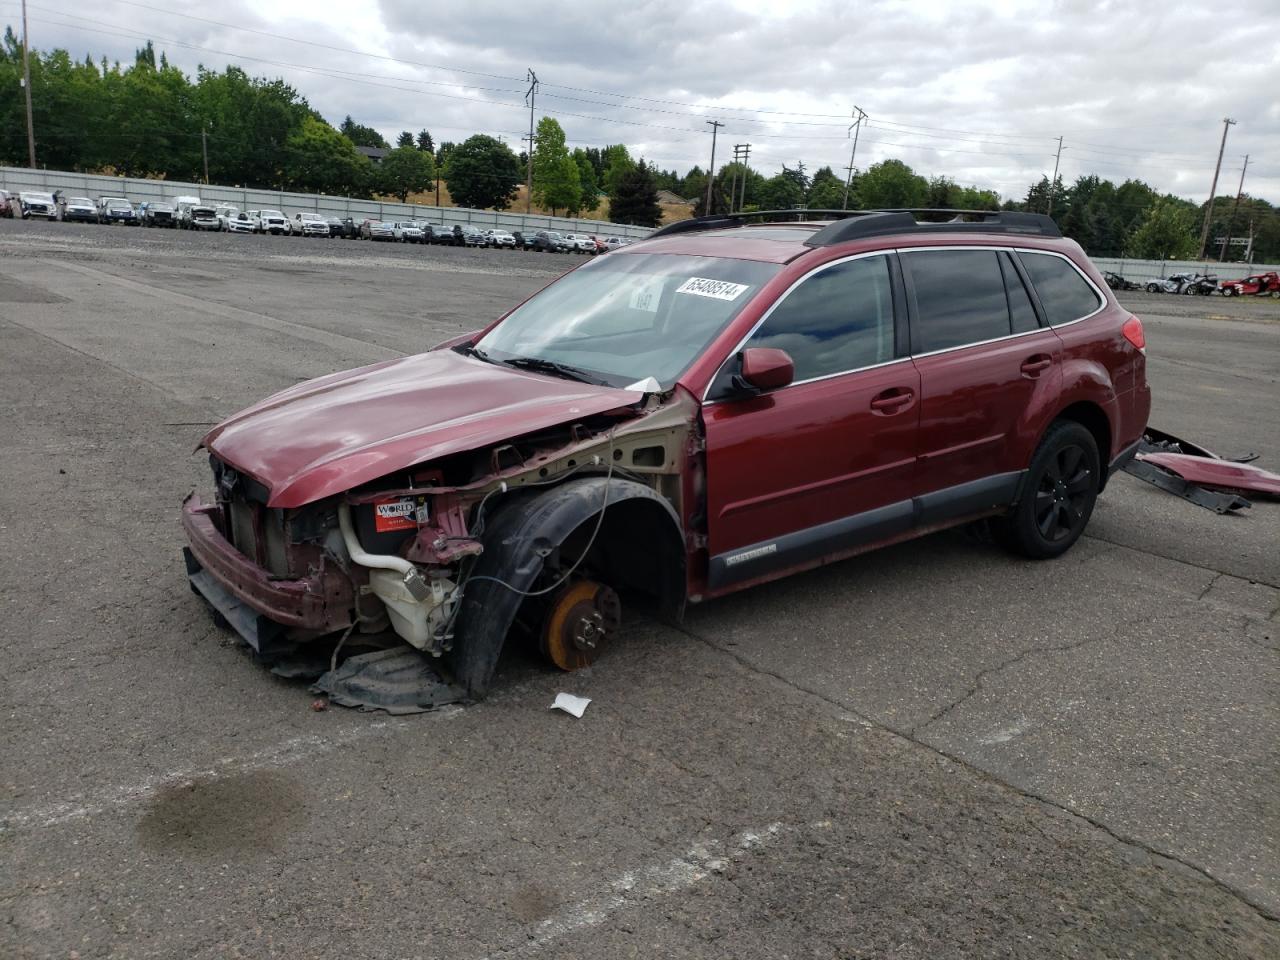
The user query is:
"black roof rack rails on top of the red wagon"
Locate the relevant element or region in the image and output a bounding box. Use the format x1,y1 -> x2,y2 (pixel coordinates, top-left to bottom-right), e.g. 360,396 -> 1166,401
646,207 -> 1062,247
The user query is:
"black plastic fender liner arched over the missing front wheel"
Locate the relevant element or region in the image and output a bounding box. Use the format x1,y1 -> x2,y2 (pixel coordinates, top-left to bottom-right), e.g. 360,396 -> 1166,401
447,476 -> 685,699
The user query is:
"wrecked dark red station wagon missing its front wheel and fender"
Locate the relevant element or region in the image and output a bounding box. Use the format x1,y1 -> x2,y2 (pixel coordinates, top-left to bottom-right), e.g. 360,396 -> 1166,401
182,211 -> 1151,701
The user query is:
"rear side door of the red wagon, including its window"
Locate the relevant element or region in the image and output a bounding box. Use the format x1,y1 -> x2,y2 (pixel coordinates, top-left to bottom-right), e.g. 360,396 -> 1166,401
900,247 -> 1062,526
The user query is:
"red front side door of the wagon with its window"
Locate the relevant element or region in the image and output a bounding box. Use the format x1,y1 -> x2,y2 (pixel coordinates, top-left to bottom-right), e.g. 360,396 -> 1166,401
703,253 -> 920,590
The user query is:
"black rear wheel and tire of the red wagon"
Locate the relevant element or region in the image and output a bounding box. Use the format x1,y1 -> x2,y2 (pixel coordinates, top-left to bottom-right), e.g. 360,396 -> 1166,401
992,420 -> 1101,559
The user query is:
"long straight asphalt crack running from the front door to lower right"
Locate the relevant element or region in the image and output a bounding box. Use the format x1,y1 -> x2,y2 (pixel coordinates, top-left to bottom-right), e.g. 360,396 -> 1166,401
673,619 -> 1280,923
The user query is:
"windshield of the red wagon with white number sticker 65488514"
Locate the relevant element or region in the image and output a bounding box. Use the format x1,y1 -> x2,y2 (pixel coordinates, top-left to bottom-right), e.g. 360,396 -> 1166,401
476,253 -> 782,388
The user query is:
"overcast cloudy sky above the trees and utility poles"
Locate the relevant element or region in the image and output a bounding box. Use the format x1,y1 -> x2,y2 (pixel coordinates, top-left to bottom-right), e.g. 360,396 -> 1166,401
0,0 -> 1280,204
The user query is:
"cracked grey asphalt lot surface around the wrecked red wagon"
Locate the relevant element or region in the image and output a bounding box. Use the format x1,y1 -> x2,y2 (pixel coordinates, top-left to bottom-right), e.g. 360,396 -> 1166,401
0,220 -> 1280,960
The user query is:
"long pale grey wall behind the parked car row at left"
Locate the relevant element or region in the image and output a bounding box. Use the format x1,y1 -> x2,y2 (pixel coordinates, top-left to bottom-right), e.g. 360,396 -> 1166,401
0,166 -> 652,239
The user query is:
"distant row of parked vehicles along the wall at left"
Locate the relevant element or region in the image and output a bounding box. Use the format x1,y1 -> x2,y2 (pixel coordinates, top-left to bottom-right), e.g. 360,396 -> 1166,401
0,191 -> 631,256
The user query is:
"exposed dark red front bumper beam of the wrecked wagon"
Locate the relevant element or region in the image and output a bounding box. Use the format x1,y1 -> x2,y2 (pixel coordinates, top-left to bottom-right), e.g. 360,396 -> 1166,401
182,494 -> 353,632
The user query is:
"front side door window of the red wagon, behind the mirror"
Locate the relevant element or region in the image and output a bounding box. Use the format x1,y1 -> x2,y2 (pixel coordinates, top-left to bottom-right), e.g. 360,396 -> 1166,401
744,256 -> 893,383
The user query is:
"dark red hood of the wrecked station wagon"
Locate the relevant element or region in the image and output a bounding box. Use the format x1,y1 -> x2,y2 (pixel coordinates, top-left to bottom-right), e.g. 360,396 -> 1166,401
201,349 -> 641,507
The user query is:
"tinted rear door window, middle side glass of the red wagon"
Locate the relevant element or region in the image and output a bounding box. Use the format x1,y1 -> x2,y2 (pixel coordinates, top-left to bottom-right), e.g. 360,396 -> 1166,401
902,250 -> 1010,353
